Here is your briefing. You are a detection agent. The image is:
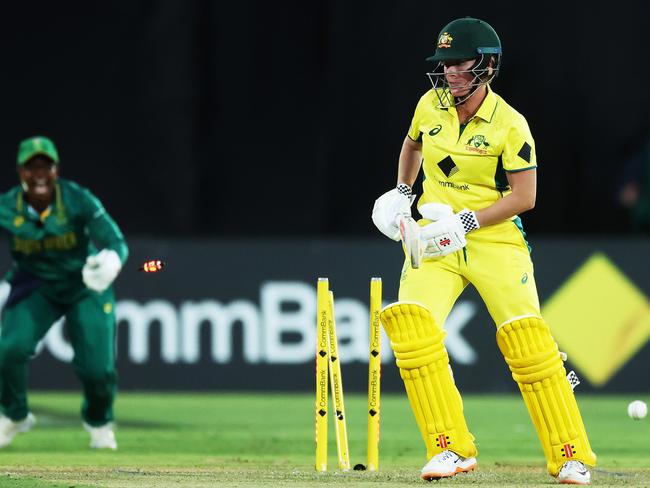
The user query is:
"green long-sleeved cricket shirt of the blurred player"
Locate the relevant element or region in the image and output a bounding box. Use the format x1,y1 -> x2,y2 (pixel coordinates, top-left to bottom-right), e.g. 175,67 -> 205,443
0,178 -> 128,291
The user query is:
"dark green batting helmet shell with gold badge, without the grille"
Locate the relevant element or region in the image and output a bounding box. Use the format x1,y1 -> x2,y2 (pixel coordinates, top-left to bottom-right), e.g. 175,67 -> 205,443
426,17 -> 501,61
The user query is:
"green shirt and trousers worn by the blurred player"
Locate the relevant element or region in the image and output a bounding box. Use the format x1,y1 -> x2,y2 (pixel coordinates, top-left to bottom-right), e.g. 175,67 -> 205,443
0,179 -> 128,426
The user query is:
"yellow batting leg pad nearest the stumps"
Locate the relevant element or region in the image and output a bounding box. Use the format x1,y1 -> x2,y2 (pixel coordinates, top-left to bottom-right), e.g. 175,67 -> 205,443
380,303 -> 476,458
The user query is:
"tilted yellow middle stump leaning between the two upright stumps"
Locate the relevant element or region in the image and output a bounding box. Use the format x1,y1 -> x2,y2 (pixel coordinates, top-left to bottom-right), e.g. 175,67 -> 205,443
328,291 -> 350,471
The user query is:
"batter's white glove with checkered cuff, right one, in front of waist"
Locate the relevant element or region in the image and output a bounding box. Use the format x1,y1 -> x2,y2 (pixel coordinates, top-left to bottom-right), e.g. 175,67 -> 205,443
420,209 -> 480,258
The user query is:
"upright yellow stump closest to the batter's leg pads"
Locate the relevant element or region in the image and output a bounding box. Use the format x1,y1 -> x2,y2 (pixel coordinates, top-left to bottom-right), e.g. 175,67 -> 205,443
367,278 -> 381,471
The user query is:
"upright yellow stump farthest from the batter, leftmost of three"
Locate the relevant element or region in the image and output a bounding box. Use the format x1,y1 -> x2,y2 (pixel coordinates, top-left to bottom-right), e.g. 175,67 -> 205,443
314,278 -> 331,471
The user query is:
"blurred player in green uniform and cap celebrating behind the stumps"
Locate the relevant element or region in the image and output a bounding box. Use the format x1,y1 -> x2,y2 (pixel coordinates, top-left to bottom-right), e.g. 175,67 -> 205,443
0,136 -> 128,449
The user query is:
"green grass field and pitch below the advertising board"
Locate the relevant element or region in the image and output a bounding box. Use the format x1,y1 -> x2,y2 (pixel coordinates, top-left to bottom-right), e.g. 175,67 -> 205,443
0,393 -> 650,488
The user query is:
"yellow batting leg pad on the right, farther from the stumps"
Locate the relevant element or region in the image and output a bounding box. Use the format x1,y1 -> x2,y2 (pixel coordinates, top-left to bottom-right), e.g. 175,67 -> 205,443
497,317 -> 596,476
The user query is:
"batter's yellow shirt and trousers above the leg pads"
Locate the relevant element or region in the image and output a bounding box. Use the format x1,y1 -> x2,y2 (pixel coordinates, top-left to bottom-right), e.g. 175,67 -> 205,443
399,86 -> 540,325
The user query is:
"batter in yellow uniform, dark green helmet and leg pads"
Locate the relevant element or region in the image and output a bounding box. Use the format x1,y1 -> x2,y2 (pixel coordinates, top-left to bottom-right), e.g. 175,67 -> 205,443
373,17 -> 596,485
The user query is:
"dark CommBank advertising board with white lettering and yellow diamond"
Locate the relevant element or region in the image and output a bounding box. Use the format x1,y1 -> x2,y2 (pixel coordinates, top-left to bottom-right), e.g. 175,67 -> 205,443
0,239 -> 650,392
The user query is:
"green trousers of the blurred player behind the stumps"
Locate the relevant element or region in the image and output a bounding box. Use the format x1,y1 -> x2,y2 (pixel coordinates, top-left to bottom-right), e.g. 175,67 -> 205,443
0,288 -> 117,427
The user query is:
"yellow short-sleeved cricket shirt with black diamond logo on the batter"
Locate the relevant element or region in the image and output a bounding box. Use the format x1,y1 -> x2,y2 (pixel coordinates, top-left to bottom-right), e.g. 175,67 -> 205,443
408,86 -> 537,215
